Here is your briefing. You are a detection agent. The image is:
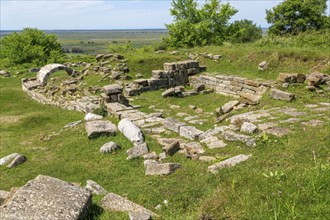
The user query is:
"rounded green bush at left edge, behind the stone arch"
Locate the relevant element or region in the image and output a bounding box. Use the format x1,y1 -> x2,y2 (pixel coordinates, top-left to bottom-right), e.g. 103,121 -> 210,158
0,28 -> 63,65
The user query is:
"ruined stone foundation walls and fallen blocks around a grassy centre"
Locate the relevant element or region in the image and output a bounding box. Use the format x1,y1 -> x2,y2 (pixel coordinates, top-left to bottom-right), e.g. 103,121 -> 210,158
14,55 -> 330,219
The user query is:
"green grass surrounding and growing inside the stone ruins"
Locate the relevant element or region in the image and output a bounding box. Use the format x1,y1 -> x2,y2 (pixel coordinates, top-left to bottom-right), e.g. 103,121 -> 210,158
0,31 -> 330,220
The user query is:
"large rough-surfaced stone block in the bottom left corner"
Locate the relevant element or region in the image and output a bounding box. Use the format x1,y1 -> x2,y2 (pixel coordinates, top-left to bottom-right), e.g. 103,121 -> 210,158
0,175 -> 92,220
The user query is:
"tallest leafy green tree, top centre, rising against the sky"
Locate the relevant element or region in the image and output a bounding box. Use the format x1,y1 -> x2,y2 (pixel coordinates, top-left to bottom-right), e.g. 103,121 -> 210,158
165,0 -> 237,47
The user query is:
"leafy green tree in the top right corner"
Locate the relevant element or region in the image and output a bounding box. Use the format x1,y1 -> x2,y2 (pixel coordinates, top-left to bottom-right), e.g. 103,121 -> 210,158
266,0 -> 329,35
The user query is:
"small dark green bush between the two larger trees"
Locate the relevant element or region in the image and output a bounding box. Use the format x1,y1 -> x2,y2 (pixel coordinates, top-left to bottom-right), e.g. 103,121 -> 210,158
228,19 -> 262,43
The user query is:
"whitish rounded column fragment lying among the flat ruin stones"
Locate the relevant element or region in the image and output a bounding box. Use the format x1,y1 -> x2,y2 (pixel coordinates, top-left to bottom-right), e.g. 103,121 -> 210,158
118,118 -> 144,144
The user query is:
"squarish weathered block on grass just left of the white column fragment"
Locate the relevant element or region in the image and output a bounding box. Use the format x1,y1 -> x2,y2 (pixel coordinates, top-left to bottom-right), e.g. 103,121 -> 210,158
85,120 -> 117,139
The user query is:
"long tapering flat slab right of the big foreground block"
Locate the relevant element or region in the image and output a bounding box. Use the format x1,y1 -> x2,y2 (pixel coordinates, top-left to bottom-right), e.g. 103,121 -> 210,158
101,193 -> 157,217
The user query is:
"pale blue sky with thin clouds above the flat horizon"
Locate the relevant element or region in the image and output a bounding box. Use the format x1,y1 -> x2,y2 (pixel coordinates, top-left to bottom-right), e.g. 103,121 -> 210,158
0,0 -> 328,30
